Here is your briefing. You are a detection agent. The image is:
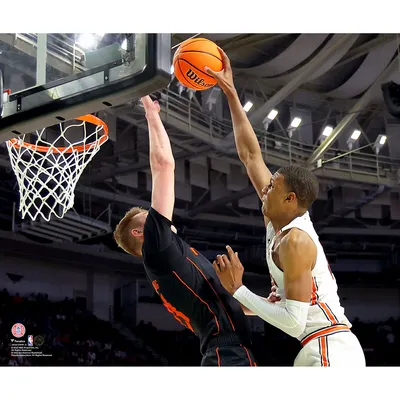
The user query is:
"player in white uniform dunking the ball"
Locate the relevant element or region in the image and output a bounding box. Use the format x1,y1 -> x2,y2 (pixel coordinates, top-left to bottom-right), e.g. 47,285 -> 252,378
208,50 -> 365,366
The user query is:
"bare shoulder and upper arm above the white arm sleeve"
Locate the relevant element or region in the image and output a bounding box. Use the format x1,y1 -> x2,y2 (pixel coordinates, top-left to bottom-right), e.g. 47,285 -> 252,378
279,228 -> 317,302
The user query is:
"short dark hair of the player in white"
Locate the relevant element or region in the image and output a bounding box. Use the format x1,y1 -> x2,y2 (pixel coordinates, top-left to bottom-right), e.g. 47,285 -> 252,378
277,165 -> 319,210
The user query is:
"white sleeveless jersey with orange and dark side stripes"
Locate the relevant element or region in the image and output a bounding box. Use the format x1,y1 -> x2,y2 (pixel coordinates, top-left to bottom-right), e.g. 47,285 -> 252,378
266,212 -> 351,340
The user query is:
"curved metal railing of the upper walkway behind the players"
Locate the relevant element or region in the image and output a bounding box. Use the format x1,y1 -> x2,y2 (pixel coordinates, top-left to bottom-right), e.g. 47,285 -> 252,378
161,89 -> 400,179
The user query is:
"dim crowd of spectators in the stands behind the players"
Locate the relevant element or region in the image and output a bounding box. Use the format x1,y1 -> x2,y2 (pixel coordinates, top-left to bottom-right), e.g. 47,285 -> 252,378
0,290 -> 400,366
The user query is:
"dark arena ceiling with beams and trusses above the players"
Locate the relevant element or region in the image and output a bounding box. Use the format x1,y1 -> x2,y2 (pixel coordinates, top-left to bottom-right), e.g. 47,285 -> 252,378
0,33 -> 400,266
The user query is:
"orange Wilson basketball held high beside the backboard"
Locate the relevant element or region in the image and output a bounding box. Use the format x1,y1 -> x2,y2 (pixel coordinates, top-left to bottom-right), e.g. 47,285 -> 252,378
173,38 -> 223,90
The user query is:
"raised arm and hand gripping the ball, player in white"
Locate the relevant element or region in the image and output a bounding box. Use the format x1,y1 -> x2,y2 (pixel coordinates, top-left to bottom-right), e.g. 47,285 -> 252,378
207,48 -> 271,205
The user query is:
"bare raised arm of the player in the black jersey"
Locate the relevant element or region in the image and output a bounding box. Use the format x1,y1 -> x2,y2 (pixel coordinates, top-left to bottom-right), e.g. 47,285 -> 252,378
141,96 -> 175,221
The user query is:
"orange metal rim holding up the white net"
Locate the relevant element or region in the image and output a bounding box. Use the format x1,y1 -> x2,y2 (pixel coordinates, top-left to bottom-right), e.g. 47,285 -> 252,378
9,114 -> 108,153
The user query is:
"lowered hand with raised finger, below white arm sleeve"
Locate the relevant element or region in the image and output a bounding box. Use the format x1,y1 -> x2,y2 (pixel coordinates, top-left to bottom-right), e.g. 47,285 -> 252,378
213,246 -> 244,295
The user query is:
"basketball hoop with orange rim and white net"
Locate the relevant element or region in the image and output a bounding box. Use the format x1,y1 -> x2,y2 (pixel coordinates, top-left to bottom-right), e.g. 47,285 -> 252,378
6,115 -> 108,221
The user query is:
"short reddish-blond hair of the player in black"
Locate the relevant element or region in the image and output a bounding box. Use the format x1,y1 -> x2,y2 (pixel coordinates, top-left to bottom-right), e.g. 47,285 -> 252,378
114,207 -> 147,256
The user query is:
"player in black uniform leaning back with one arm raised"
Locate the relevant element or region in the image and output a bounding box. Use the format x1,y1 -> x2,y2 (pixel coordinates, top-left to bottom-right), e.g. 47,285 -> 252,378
114,96 -> 256,366
